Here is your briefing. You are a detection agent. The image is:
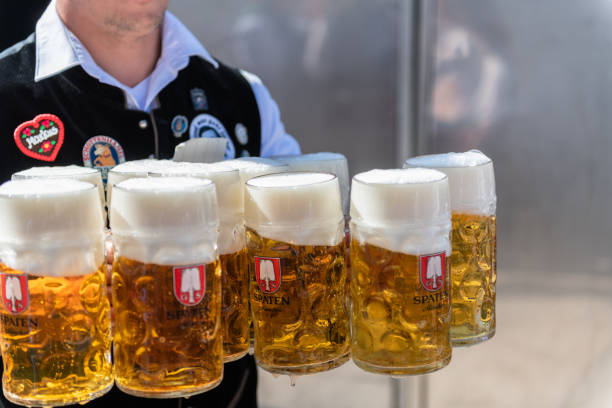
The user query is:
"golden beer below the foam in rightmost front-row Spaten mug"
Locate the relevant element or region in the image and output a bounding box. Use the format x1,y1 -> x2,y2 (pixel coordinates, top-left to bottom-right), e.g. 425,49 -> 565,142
351,241 -> 451,375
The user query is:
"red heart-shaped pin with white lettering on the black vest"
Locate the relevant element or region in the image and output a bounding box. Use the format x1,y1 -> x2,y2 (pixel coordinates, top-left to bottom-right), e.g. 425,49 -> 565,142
14,113 -> 64,162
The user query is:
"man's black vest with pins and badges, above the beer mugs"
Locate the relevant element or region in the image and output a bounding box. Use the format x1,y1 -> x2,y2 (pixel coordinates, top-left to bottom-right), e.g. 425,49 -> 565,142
0,35 -> 261,181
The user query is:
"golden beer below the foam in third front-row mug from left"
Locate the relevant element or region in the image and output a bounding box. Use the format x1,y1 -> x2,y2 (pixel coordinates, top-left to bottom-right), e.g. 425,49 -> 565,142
247,229 -> 350,374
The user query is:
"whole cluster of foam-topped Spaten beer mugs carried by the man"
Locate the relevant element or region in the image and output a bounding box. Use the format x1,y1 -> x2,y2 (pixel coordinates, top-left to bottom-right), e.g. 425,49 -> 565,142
0,151 -> 496,406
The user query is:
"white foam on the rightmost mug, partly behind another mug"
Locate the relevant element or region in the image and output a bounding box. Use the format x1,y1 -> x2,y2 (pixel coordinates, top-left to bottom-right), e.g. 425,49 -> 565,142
404,150 -> 497,215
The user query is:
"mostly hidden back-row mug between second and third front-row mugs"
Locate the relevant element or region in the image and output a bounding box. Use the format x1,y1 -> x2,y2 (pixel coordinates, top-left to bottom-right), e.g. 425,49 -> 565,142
150,163 -> 251,362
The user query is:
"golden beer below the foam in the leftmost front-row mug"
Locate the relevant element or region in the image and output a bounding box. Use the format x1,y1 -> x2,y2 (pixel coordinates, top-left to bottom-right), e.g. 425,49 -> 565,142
0,264 -> 113,406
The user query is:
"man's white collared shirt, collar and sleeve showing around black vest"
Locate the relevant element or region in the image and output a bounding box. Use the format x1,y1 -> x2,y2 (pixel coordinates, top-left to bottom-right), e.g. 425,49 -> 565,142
34,0 -> 300,157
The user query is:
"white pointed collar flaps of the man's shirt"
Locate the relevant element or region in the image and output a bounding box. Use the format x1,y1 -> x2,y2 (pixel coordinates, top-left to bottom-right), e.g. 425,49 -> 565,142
34,0 -> 219,85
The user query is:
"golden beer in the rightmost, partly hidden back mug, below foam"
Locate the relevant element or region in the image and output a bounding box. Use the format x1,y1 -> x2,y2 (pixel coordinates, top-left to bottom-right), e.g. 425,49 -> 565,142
450,214 -> 497,344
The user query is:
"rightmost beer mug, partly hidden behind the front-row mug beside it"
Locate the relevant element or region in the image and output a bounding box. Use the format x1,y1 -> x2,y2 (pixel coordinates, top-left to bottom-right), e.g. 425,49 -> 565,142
406,150 -> 497,346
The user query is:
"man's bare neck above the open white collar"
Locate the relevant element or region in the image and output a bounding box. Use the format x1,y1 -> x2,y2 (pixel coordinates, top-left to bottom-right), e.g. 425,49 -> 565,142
58,5 -> 161,88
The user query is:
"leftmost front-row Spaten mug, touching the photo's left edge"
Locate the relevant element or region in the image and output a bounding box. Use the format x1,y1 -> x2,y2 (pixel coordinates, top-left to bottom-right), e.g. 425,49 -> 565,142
0,179 -> 113,406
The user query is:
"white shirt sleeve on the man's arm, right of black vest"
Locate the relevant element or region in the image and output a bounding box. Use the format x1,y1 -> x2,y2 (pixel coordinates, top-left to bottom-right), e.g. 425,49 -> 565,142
241,71 -> 301,157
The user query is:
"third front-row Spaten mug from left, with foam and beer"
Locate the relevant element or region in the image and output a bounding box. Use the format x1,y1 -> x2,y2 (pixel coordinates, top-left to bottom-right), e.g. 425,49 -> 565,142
245,173 -> 349,374
